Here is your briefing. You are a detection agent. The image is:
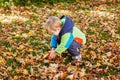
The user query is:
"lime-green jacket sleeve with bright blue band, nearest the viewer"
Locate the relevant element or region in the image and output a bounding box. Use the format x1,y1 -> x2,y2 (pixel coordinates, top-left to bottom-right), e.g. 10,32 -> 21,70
55,33 -> 74,54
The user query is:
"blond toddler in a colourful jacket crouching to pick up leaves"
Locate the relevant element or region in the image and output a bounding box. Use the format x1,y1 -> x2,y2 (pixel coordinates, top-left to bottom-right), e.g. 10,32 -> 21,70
44,15 -> 86,60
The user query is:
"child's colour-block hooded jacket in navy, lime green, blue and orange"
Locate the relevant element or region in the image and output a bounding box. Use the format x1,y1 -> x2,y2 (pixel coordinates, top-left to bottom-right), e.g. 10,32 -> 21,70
50,16 -> 86,53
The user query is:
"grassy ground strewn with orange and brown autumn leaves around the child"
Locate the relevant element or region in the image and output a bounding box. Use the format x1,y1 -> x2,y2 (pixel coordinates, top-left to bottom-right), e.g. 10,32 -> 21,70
0,1 -> 120,80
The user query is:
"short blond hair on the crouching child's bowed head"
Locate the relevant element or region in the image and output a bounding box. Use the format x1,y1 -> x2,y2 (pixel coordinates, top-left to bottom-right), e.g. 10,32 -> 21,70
44,16 -> 62,30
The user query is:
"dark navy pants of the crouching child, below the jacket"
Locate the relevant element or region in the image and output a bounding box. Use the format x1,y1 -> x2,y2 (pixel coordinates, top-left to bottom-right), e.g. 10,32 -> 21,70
68,41 -> 81,56
